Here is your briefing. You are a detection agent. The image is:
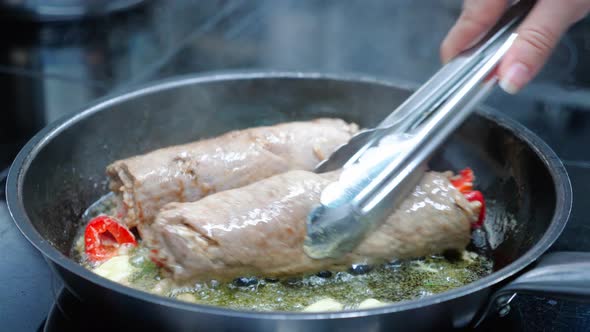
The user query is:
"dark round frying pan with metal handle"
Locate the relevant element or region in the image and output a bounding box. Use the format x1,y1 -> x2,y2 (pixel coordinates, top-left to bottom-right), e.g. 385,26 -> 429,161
7,72 -> 590,331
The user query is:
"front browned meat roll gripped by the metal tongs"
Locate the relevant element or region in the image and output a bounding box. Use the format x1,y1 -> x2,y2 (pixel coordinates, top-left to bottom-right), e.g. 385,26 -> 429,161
140,171 -> 480,280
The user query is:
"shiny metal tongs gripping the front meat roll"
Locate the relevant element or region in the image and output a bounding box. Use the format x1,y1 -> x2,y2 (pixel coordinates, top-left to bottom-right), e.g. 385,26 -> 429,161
304,1 -> 533,259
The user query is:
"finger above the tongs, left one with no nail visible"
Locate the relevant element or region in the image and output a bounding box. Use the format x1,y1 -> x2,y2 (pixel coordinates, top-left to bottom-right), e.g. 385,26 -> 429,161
440,0 -> 508,62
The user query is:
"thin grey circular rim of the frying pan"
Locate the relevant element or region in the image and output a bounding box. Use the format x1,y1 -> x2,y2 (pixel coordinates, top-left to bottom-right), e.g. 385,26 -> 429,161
6,71 -> 572,320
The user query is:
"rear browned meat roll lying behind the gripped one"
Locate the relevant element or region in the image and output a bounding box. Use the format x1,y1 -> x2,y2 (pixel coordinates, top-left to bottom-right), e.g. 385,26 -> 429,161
107,119 -> 358,227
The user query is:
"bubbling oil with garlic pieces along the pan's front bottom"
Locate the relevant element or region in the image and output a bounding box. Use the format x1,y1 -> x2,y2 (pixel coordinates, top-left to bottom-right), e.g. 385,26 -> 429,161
71,194 -> 493,311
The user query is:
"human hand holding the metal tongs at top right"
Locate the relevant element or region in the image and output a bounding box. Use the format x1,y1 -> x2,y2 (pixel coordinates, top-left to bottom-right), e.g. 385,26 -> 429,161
441,0 -> 590,94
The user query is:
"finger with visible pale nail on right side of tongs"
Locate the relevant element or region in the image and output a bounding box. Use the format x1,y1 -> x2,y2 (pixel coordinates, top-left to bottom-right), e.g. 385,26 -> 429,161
498,0 -> 590,94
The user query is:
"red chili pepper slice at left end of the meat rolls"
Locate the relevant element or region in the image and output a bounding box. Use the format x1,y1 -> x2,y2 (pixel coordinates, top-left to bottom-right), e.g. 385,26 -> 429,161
84,216 -> 137,262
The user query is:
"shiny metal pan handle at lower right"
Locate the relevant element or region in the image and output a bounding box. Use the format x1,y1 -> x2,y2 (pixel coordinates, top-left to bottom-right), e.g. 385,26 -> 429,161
474,251 -> 590,327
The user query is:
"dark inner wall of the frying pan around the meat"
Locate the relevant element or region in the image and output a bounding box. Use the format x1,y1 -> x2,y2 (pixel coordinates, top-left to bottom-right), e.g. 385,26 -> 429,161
9,76 -> 572,318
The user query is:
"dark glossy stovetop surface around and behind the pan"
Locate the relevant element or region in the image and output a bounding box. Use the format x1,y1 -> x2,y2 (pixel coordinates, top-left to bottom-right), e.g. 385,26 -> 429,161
0,0 -> 590,331
